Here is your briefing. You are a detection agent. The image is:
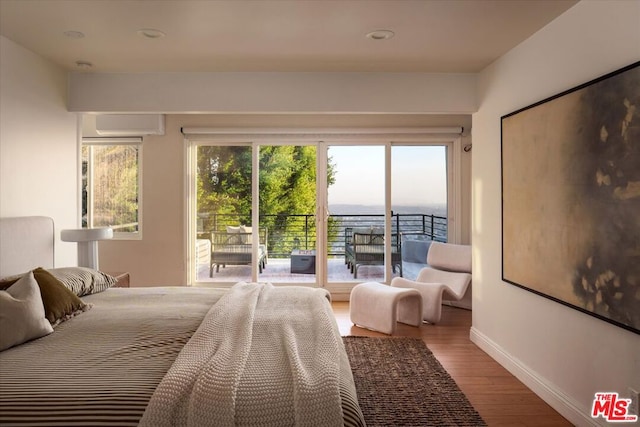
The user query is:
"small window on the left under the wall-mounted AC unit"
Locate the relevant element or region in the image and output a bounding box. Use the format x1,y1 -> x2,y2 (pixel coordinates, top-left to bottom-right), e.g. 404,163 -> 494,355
82,138 -> 142,239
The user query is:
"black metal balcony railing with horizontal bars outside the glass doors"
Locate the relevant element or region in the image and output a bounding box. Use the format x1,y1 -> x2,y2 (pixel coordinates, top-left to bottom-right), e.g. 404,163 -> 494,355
198,213 -> 447,258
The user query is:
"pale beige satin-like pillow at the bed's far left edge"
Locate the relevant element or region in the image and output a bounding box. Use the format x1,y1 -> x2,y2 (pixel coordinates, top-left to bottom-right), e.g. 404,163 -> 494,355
0,272 -> 53,351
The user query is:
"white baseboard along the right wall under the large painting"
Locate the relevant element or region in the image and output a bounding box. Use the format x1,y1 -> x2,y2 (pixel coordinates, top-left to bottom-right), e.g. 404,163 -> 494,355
469,327 -> 606,426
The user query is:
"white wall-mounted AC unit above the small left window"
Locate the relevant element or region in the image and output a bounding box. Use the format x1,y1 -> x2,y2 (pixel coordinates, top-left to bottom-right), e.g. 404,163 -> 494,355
96,114 -> 164,136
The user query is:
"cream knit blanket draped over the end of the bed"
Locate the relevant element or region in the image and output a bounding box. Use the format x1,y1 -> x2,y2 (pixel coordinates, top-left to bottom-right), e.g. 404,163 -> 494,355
140,282 -> 344,427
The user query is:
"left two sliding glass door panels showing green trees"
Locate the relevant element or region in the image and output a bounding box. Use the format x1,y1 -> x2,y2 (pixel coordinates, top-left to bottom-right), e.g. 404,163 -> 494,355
194,143 -> 317,284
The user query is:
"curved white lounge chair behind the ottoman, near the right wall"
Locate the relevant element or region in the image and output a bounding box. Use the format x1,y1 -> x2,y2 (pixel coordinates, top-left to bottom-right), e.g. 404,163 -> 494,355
391,242 -> 471,323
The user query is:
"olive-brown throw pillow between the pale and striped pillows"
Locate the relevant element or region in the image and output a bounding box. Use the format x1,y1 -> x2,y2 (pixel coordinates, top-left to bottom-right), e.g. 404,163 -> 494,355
33,267 -> 91,326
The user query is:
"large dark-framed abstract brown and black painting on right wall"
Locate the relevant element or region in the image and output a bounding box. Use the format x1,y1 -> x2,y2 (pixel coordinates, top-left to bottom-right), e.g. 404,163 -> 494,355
501,62 -> 640,334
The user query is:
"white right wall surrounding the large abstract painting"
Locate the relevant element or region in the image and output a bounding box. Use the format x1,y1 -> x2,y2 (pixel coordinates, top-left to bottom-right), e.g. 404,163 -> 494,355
471,0 -> 640,425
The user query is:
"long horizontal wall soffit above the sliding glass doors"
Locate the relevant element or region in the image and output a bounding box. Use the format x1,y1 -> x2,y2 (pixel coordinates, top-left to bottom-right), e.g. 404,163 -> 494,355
69,72 -> 477,114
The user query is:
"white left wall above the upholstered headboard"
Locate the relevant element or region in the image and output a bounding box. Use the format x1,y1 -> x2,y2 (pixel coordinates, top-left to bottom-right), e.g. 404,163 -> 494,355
0,36 -> 79,266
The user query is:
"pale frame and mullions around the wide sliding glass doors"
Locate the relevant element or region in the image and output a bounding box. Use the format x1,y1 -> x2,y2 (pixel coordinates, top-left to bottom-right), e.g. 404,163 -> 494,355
182,127 -> 462,295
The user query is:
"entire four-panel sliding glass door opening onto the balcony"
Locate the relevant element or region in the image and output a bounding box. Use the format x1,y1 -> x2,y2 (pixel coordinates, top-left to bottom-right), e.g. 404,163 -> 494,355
188,132 -> 458,292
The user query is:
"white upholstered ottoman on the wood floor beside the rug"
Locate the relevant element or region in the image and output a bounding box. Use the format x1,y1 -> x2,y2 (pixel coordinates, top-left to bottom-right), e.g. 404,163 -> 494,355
349,282 -> 422,334
